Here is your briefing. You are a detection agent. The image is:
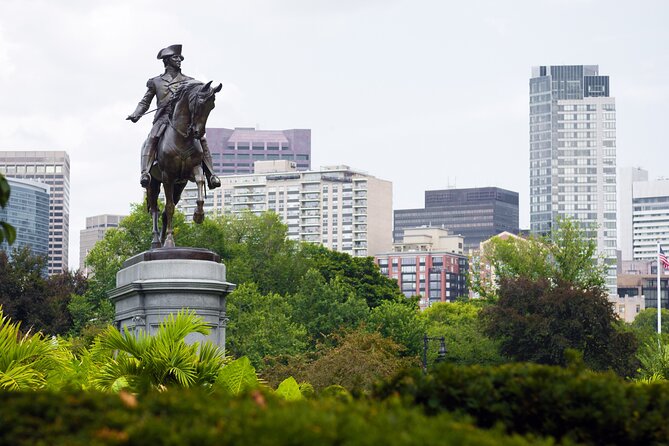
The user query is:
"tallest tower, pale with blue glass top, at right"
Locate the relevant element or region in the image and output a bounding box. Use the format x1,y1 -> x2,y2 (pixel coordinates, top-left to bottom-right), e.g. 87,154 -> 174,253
530,65 -> 617,294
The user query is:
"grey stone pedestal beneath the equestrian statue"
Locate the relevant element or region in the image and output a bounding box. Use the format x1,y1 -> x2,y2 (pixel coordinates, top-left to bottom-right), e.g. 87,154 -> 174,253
109,248 -> 235,348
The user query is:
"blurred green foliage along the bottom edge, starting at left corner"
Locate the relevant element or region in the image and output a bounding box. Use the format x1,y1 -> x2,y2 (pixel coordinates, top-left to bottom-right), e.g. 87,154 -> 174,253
0,390 -> 553,446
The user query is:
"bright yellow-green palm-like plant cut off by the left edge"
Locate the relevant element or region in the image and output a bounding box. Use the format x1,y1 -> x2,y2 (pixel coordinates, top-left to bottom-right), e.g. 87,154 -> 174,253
0,308 -> 70,390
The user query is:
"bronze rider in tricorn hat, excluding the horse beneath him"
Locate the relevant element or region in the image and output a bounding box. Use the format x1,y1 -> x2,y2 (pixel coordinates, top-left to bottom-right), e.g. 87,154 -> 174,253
126,45 -> 221,189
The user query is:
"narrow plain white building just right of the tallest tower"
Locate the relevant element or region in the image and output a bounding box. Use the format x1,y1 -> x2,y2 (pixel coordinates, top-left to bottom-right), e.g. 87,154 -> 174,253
618,167 -> 648,262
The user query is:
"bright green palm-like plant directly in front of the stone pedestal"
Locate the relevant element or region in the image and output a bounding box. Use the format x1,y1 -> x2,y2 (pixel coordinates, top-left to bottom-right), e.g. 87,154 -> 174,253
93,310 -> 226,392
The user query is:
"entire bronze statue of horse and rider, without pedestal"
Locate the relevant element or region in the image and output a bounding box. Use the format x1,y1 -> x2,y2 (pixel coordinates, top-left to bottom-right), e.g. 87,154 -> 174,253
127,45 -> 222,249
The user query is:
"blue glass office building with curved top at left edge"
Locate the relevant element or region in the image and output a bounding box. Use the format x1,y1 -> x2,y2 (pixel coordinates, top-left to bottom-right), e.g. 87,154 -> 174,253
0,177 -> 49,264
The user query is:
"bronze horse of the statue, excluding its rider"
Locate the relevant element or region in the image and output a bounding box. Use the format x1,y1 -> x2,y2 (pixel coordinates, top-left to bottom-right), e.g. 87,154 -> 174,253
146,81 -> 222,249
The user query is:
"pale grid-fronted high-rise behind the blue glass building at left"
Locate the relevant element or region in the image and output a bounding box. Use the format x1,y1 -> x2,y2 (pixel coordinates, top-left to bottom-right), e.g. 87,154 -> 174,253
0,151 -> 70,274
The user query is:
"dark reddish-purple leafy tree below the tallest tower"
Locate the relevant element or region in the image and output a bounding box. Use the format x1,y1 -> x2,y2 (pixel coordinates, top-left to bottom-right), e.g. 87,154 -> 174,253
482,277 -> 637,376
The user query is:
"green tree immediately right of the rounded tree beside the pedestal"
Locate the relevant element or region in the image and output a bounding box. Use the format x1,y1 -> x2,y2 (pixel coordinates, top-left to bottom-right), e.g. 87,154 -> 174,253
289,269 -> 369,345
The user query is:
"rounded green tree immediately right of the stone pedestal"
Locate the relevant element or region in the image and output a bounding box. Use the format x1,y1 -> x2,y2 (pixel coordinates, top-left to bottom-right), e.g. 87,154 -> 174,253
226,283 -> 307,368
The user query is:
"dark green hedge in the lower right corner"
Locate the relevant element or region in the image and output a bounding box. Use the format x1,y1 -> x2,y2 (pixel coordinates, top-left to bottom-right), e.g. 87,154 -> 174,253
375,363 -> 669,445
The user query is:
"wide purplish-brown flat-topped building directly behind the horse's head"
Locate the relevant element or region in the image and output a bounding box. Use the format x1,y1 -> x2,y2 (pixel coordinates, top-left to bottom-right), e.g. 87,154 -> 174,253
207,128 -> 311,175
